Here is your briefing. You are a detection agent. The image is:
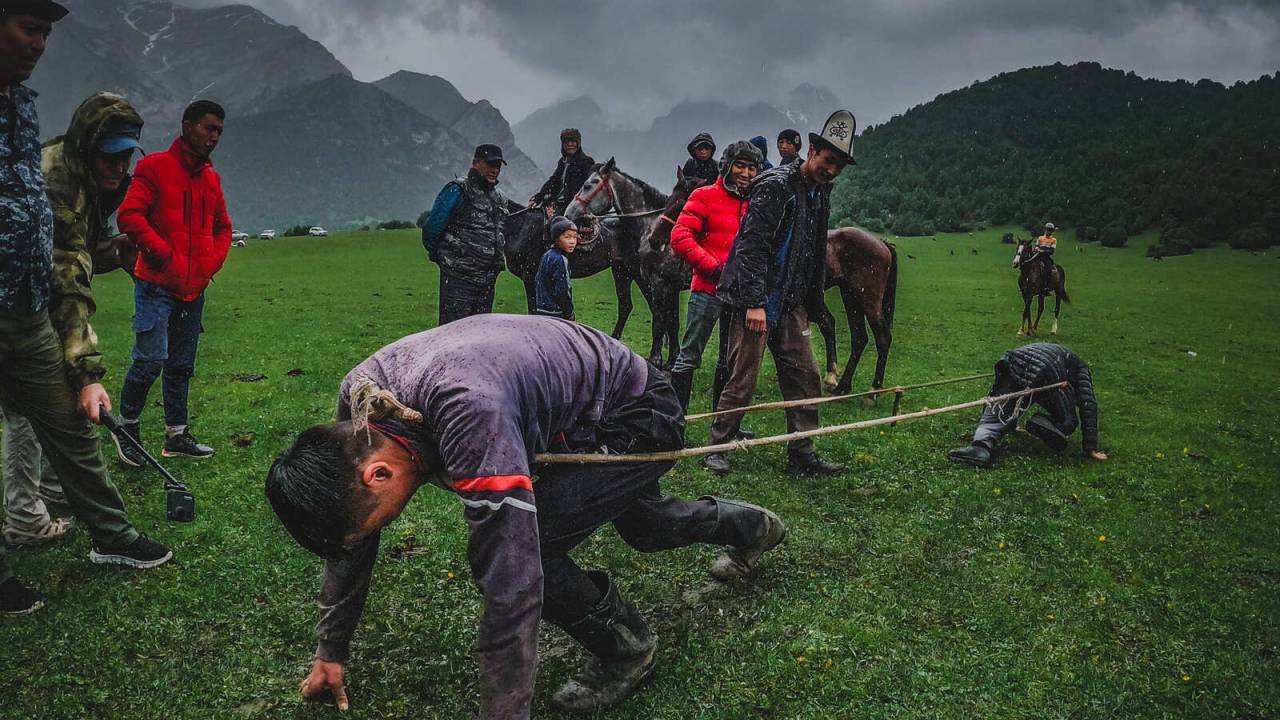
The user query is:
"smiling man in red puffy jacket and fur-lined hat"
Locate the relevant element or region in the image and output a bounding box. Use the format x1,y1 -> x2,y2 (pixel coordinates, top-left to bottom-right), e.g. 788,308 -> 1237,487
671,141 -> 763,425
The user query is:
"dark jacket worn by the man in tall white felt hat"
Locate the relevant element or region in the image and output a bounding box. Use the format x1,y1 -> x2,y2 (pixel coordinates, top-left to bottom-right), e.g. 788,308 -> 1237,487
716,165 -> 831,324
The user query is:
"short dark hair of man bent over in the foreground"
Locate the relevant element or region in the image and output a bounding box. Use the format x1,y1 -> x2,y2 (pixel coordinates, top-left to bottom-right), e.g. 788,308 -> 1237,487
266,423 -> 384,560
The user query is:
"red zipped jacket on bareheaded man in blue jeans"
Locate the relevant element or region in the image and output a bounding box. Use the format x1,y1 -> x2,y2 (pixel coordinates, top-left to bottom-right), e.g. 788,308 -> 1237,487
116,137 -> 232,301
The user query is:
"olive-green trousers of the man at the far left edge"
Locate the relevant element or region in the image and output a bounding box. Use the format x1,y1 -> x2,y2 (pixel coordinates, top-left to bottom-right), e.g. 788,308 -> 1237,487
0,310 -> 138,582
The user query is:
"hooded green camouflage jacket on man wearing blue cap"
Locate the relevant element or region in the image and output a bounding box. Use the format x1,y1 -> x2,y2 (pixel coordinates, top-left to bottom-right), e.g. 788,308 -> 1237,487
41,92 -> 142,387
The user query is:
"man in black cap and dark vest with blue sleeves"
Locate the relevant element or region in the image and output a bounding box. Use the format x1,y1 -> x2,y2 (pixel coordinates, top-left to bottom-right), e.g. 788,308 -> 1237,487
422,145 -> 508,325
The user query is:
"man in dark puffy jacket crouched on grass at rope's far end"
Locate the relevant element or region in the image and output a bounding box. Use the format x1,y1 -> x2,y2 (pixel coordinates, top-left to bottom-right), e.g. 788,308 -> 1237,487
950,342 -> 1107,468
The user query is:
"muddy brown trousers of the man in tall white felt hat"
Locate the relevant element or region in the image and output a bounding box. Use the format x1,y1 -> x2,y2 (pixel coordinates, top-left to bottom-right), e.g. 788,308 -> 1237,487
710,307 -> 822,455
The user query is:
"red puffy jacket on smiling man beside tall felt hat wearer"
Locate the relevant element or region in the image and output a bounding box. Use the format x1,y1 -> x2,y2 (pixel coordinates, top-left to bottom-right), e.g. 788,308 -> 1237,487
671,176 -> 746,295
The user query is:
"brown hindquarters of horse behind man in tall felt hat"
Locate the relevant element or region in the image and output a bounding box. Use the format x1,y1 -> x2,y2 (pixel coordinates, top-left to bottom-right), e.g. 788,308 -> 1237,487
813,228 -> 897,395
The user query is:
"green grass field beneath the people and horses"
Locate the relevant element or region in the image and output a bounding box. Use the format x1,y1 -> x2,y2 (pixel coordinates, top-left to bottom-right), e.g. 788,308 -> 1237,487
0,229 -> 1280,720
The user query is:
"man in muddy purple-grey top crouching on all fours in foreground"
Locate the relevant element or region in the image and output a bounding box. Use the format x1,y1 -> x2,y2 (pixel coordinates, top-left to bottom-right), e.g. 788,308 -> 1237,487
266,315 -> 786,719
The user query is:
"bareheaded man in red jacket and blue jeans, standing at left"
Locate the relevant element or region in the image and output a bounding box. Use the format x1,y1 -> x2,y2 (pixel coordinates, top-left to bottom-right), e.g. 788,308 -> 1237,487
115,100 -> 232,466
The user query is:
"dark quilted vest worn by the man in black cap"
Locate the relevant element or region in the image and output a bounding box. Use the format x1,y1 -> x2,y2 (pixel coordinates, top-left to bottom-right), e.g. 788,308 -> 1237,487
435,170 -> 507,284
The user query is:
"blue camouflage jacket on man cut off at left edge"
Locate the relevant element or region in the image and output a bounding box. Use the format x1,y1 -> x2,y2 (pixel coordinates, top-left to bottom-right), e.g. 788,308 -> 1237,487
0,83 -> 54,313
